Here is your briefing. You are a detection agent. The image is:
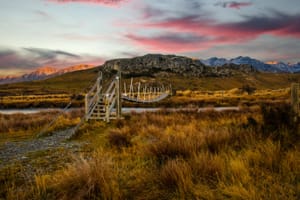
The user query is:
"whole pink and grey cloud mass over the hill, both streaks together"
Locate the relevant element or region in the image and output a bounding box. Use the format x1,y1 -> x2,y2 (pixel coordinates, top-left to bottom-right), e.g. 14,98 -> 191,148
125,10 -> 300,52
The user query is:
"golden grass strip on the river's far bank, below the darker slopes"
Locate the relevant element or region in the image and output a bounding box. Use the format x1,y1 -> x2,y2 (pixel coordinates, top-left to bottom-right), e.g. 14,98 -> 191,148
0,88 -> 290,109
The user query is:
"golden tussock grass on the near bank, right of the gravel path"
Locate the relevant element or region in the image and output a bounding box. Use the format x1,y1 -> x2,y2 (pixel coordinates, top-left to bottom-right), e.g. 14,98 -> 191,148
0,103 -> 300,199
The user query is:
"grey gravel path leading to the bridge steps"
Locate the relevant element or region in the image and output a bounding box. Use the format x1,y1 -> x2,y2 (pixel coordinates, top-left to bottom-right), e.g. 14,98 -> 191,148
0,128 -> 81,169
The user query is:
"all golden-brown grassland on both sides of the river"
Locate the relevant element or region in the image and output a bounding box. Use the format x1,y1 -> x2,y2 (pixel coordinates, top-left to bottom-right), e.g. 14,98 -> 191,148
0,69 -> 300,200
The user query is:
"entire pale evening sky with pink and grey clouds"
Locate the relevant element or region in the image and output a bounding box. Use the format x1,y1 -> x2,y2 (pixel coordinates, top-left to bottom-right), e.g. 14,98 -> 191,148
0,0 -> 300,76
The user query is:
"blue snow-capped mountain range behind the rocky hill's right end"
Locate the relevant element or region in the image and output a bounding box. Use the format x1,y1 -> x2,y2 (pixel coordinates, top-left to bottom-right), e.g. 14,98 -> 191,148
200,56 -> 300,73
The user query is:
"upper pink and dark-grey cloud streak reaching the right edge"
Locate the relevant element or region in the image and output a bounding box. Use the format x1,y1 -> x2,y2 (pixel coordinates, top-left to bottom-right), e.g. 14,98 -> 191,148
139,14 -> 300,41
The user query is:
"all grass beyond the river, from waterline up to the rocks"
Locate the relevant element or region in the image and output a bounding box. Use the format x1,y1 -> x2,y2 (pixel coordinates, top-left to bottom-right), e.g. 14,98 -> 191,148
0,68 -> 300,108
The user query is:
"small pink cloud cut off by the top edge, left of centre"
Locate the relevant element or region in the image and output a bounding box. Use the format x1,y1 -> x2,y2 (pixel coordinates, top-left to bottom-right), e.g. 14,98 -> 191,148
46,0 -> 130,7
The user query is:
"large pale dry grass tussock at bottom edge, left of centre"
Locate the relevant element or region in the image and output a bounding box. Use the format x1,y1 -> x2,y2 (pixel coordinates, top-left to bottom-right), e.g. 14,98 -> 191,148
49,152 -> 120,199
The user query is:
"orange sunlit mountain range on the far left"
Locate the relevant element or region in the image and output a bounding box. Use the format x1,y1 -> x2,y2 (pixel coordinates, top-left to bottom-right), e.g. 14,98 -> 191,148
0,64 -> 95,84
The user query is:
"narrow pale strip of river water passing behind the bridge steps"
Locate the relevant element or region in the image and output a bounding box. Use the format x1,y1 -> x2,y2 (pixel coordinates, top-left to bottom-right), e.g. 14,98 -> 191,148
0,107 -> 239,115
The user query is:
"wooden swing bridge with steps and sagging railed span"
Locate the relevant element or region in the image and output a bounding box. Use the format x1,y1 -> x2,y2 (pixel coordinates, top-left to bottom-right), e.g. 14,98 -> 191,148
85,72 -> 172,122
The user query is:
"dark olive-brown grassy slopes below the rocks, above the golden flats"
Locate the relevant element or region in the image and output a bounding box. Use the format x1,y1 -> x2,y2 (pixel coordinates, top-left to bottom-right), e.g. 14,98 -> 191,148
0,68 -> 300,97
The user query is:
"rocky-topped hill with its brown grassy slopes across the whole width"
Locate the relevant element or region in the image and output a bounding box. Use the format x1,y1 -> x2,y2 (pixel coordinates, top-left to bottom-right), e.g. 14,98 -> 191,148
0,55 -> 300,96
